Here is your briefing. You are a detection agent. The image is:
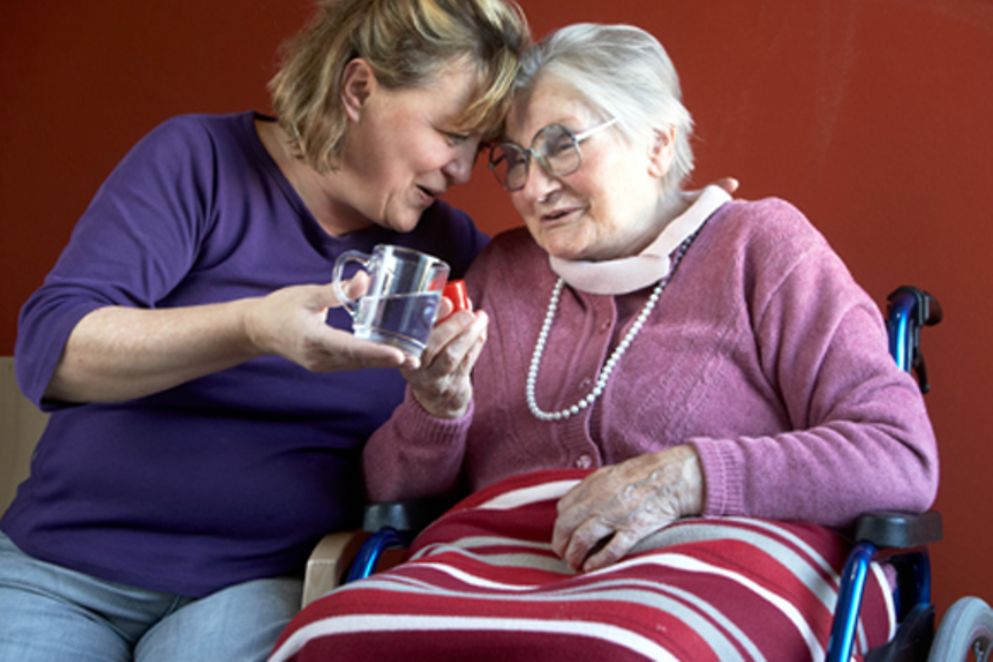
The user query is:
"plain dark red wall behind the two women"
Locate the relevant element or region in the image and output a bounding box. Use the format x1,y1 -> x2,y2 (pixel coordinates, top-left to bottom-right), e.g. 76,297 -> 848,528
0,0 -> 993,609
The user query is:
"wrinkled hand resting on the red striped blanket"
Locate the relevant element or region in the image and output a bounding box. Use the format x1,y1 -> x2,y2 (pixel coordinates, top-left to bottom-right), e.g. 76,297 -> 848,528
552,444 -> 703,571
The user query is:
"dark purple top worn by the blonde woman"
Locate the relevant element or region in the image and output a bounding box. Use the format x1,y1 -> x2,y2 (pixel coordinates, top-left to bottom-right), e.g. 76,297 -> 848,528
0,113 -> 486,596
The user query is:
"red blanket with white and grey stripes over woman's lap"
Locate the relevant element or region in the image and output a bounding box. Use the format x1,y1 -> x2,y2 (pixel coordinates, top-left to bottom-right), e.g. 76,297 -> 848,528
271,470 -> 894,662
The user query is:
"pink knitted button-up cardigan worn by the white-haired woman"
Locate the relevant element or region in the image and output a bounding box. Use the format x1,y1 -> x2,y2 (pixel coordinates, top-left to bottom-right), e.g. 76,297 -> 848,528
364,199 -> 938,525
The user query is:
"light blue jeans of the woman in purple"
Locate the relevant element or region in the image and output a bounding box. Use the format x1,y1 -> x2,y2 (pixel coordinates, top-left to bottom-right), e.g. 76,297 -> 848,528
0,533 -> 303,662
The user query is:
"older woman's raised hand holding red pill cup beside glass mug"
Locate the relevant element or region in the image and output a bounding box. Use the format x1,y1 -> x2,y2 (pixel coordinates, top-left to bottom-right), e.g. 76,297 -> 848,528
401,310 -> 489,418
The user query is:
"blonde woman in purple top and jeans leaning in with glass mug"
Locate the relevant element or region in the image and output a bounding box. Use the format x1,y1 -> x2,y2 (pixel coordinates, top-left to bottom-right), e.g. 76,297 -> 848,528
0,0 -> 530,662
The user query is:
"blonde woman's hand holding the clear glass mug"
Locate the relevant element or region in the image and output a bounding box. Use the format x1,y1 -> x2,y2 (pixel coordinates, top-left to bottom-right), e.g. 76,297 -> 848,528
243,279 -> 416,372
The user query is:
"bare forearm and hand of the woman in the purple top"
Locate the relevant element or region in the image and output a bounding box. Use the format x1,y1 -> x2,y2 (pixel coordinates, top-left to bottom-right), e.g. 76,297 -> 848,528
45,285 -> 410,402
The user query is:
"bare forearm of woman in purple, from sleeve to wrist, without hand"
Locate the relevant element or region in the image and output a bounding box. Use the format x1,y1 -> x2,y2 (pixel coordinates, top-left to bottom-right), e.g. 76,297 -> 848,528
45,299 -> 260,402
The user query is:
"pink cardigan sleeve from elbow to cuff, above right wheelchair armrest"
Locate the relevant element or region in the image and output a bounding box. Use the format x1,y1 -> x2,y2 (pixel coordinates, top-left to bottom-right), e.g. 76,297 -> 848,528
691,395 -> 937,526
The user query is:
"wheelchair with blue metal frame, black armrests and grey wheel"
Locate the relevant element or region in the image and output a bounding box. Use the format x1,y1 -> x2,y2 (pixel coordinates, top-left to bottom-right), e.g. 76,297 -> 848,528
330,286 -> 993,662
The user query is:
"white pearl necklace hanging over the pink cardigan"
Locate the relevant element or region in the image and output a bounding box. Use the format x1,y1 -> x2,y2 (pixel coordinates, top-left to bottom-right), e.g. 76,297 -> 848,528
525,239 -> 696,421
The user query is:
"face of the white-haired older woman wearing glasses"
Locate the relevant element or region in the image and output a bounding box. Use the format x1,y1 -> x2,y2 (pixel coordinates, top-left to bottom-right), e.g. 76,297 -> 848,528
507,78 -> 660,260
